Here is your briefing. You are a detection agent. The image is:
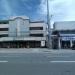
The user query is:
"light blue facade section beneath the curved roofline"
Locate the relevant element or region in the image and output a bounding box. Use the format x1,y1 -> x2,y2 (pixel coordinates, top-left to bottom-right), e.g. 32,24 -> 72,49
9,18 -> 29,37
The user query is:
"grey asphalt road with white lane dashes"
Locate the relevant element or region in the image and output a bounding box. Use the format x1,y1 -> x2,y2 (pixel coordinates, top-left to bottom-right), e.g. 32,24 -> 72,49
0,50 -> 75,75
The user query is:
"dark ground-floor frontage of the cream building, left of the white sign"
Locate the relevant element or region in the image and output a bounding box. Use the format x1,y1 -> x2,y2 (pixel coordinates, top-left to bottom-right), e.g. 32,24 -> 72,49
0,41 -> 41,48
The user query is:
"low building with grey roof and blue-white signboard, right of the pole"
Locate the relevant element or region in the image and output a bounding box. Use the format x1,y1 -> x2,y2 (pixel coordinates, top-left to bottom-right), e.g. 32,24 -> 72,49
52,21 -> 75,49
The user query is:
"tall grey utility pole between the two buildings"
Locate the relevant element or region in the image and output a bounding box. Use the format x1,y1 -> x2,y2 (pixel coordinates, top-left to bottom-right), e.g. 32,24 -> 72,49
47,0 -> 52,49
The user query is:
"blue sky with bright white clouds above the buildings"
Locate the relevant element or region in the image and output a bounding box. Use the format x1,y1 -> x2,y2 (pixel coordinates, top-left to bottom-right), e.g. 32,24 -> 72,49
0,0 -> 75,21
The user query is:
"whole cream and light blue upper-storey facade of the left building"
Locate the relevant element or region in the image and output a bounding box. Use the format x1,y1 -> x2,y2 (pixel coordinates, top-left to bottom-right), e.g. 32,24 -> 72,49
0,17 -> 47,41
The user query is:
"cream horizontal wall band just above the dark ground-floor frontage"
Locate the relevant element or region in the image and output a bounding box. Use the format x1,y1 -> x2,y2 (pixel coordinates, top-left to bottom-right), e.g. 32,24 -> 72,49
0,37 -> 46,42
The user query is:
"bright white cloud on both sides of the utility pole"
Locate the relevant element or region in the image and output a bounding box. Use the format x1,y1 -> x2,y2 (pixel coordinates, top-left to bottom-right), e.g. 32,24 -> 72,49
37,0 -> 75,21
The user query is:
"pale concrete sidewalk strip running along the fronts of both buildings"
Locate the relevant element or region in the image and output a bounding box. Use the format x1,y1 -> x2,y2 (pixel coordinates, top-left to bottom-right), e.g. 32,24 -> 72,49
0,48 -> 75,53
